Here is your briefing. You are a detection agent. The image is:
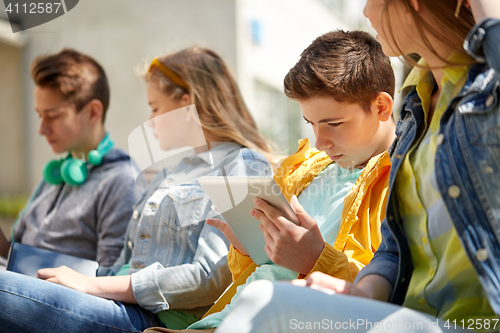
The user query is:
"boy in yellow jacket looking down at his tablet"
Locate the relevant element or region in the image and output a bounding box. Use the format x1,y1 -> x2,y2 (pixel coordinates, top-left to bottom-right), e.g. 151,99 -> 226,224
149,31 -> 396,332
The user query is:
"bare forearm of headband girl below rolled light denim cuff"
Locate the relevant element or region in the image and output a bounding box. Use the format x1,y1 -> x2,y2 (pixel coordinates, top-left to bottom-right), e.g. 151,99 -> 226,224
86,275 -> 137,304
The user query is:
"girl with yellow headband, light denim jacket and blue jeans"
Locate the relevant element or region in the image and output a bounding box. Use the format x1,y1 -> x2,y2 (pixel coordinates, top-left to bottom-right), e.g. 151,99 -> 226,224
0,47 -> 272,333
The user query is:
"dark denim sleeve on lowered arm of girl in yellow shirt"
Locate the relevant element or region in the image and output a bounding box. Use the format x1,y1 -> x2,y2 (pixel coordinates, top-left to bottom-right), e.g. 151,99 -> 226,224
354,219 -> 399,287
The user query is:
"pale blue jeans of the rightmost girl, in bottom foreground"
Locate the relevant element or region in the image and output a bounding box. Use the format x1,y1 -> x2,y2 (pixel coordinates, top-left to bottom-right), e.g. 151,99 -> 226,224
217,280 -> 465,333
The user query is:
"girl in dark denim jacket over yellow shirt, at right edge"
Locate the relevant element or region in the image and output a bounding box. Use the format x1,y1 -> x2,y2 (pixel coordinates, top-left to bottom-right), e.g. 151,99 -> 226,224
214,0 -> 500,332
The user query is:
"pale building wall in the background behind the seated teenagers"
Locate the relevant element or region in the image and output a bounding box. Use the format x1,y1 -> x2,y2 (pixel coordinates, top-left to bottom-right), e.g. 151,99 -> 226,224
0,0 -> 400,195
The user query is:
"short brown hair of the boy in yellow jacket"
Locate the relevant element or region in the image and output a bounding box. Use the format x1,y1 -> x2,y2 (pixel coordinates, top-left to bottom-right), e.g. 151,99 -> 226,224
284,30 -> 395,111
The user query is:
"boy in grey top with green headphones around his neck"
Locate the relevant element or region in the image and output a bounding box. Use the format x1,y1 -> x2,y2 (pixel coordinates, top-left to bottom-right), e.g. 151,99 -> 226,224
0,49 -> 142,266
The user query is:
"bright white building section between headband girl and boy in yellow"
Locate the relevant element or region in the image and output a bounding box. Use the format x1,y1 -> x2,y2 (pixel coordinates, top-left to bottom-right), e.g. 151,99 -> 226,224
237,0 -> 354,154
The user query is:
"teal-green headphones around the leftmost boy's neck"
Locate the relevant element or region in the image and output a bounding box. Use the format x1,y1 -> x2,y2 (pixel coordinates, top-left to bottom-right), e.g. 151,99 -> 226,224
43,133 -> 115,186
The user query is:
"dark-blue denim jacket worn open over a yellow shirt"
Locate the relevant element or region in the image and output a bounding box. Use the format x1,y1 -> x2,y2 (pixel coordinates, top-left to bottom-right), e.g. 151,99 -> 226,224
356,19 -> 500,315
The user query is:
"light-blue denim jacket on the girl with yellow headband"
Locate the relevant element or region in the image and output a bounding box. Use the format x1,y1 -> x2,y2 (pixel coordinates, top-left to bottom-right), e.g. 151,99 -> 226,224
99,143 -> 272,315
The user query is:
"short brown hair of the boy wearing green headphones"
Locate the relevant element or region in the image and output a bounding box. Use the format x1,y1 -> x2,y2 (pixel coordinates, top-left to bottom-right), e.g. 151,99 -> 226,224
31,49 -> 109,123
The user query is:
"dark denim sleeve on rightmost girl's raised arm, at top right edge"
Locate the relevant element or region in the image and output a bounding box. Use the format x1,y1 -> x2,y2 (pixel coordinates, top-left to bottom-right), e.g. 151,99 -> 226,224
464,18 -> 500,73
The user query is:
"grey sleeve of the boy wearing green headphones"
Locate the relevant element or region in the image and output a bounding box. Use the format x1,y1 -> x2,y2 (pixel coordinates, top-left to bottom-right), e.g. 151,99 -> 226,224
96,167 -> 142,267
